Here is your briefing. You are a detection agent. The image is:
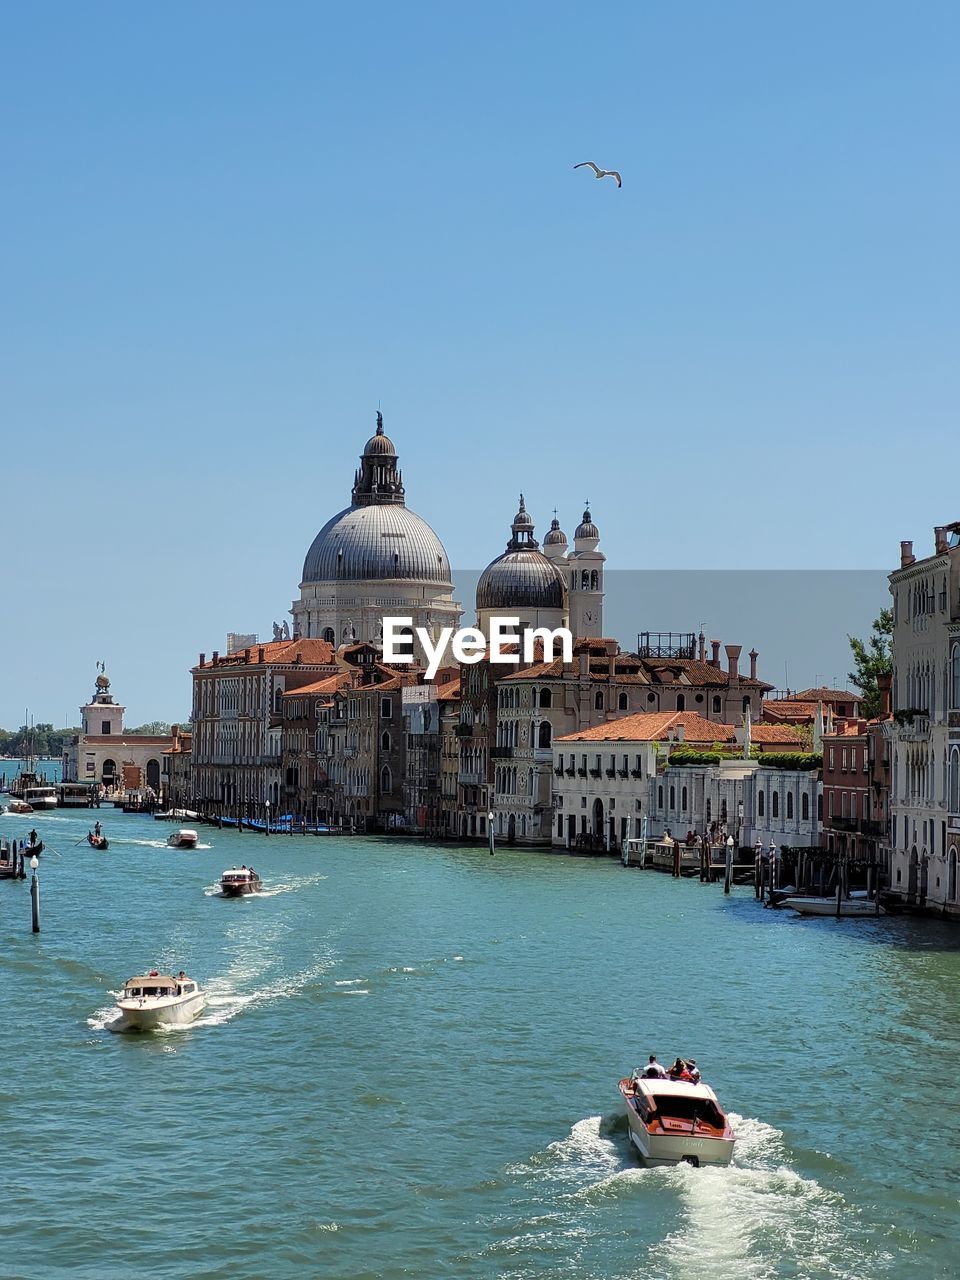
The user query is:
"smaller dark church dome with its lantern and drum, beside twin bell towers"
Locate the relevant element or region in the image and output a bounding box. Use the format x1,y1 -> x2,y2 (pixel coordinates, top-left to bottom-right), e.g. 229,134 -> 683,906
476,493 -> 567,634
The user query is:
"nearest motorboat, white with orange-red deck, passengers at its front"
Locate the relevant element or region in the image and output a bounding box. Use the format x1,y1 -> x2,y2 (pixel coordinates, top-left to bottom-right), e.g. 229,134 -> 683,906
620,1075 -> 736,1167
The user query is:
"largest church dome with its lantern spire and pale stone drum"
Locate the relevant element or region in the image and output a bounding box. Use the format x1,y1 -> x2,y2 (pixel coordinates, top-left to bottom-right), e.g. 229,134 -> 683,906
291,413 -> 461,648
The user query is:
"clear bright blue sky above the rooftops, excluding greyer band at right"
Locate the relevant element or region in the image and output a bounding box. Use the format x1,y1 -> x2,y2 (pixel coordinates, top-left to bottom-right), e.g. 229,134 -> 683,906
0,0 -> 960,724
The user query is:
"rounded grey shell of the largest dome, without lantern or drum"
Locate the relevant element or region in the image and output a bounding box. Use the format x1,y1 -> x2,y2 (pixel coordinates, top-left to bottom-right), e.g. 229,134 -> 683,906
303,503 -> 452,586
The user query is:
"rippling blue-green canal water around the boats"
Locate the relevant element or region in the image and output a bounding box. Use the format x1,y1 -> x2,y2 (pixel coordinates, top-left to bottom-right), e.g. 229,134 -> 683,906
0,808 -> 960,1280
